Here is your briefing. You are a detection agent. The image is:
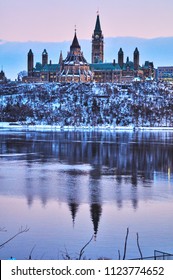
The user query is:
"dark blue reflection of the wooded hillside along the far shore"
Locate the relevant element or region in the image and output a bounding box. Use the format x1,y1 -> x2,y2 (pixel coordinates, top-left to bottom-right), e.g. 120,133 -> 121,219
0,132 -> 173,177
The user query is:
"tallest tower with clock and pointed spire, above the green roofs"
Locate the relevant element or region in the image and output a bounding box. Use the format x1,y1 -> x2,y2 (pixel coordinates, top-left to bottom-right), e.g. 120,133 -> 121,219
91,14 -> 104,63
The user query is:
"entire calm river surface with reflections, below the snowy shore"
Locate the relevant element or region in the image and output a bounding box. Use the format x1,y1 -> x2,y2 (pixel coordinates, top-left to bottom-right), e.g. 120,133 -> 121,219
0,130 -> 173,259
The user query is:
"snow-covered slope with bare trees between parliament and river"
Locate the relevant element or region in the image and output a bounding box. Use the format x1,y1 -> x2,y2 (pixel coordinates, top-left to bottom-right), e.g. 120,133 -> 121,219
0,82 -> 173,127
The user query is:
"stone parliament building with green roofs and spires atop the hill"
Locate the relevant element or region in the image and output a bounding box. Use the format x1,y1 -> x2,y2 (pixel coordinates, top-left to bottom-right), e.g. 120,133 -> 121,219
23,14 -> 154,83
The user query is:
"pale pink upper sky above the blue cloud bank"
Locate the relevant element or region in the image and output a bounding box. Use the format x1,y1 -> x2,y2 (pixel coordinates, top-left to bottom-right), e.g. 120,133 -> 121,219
0,0 -> 173,42
